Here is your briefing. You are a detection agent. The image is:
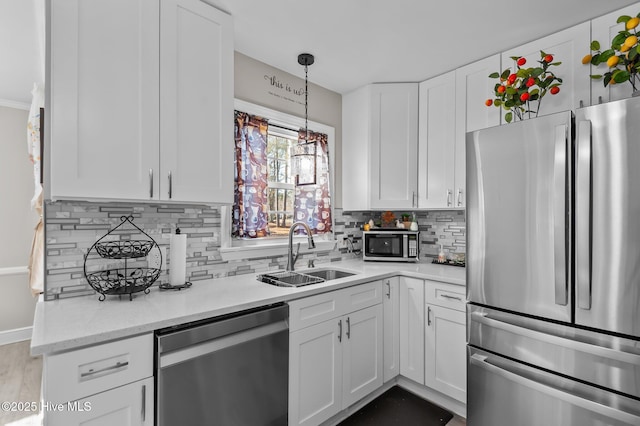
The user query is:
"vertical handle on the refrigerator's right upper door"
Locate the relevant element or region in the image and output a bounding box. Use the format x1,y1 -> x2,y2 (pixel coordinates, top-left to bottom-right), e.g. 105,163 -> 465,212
575,121 -> 591,310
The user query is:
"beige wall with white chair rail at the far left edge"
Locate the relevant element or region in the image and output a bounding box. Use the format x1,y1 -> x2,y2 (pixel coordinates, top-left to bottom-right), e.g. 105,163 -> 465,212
0,106 -> 37,342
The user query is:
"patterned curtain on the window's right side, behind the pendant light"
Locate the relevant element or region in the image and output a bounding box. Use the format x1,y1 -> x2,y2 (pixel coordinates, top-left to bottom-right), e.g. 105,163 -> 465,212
293,129 -> 331,234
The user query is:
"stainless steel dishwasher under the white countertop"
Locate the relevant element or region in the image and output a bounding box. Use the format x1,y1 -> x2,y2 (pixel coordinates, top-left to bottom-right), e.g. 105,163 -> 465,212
156,304 -> 289,426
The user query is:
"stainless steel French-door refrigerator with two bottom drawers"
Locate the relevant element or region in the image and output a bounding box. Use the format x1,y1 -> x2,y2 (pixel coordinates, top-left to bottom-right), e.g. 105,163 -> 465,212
466,98 -> 640,426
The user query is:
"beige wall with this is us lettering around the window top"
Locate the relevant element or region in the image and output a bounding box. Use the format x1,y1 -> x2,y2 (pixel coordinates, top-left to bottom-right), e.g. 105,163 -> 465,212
234,52 -> 342,208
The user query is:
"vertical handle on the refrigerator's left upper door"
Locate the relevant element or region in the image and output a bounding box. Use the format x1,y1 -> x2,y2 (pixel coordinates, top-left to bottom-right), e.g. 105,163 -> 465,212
553,125 -> 569,306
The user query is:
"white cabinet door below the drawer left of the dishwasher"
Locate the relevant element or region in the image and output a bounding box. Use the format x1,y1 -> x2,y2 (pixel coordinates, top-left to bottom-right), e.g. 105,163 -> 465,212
43,377 -> 154,426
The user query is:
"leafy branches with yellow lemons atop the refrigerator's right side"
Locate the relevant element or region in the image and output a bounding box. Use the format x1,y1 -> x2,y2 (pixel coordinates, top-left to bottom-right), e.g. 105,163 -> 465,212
582,13 -> 640,92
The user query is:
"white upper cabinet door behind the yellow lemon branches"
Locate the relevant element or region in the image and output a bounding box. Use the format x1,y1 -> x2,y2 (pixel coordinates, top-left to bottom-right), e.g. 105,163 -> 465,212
592,3 -> 640,105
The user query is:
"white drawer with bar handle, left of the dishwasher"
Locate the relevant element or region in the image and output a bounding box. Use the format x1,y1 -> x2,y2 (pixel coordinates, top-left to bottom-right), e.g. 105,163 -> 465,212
43,333 -> 153,403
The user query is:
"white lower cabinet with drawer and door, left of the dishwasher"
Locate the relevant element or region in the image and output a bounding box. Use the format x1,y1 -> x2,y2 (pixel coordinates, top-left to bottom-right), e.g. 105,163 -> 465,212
42,333 -> 154,426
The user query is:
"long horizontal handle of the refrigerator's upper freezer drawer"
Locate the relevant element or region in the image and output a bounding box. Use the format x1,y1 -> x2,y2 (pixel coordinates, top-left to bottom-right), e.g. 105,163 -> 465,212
470,312 -> 640,364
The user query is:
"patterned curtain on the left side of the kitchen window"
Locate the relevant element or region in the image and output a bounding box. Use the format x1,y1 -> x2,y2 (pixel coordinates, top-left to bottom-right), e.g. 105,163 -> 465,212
232,111 -> 269,238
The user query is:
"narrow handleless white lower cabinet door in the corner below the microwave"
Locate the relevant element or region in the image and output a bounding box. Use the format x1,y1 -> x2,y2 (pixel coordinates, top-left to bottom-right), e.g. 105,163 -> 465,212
400,277 -> 424,384
